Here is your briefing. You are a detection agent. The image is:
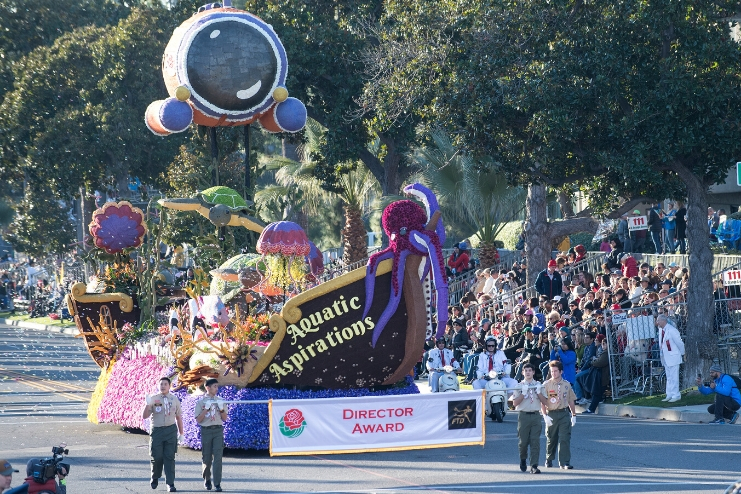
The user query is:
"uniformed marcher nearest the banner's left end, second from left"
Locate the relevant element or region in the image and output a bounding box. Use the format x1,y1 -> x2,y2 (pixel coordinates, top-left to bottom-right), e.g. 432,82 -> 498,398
194,379 -> 228,492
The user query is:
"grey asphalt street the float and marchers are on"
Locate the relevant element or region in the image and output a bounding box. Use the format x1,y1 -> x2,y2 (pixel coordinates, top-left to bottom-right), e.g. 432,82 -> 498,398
0,326 -> 741,494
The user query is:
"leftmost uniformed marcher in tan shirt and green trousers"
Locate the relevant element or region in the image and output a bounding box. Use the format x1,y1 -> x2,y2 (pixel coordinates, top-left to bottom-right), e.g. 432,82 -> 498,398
142,377 -> 184,492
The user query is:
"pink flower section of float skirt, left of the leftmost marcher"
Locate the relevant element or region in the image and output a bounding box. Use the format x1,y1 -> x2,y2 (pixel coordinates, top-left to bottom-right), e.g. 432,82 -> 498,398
98,355 -> 170,430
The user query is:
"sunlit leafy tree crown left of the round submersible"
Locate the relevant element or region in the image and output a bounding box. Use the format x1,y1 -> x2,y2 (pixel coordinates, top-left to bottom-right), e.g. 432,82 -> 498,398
0,8 -> 183,249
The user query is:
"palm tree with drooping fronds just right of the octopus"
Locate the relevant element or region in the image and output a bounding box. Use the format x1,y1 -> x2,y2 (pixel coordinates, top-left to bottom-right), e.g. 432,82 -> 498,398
412,129 -> 525,267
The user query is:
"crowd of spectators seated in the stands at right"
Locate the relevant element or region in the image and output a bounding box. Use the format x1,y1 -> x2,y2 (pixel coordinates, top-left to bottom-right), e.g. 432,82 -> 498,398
420,239 -> 741,413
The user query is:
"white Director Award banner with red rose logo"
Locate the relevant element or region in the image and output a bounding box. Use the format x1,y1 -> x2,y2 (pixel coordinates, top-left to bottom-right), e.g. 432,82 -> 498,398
269,391 -> 486,456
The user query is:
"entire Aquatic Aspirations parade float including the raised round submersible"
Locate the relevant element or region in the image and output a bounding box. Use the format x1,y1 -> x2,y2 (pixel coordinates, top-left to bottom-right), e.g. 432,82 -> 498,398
69,2 -> 448,449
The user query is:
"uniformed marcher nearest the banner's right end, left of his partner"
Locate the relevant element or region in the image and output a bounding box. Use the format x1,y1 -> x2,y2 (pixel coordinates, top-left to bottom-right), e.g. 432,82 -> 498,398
512,362 -> 546,473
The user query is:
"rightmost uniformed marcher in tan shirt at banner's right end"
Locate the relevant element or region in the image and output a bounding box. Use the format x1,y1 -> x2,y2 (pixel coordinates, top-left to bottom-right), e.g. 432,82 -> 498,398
541,360 -> 576,470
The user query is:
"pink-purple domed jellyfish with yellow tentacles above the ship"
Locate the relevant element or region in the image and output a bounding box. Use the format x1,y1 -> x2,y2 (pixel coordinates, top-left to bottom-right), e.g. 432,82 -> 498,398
257,221 -> 311,291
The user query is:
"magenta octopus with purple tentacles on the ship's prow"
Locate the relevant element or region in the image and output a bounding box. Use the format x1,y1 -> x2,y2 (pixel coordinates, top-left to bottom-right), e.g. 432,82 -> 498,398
363,184 -> 448,347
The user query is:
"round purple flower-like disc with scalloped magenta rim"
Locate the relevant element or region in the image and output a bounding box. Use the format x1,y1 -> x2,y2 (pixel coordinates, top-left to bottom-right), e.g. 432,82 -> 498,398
90,201 -> 147,254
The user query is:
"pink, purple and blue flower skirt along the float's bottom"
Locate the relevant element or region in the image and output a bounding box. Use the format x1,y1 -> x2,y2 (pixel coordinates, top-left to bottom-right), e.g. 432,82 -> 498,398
98,356 -> 419,449
